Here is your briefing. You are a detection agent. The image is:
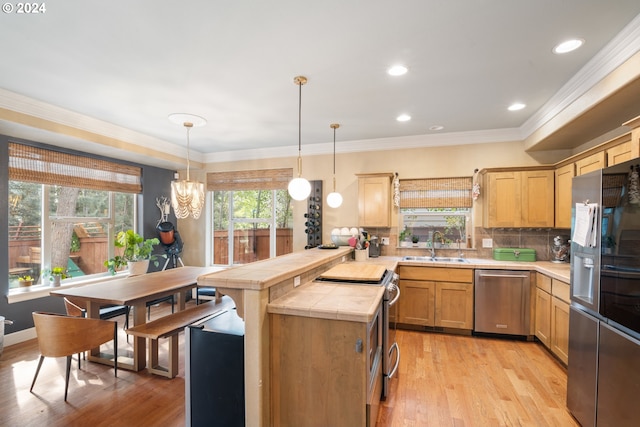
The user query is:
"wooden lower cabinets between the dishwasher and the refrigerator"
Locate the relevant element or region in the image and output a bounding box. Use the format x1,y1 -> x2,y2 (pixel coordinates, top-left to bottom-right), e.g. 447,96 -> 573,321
534,273 -> 569,364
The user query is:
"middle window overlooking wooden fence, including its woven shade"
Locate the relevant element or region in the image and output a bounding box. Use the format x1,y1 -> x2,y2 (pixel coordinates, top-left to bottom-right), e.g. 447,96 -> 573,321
207,169 -> 293,265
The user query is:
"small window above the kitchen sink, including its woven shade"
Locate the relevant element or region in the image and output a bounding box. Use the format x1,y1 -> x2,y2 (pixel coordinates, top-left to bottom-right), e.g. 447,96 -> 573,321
398,177 -> 473,249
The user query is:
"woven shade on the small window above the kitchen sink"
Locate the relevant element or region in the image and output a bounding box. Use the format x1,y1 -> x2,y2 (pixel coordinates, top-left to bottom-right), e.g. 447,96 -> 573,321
400,177 -> 473,208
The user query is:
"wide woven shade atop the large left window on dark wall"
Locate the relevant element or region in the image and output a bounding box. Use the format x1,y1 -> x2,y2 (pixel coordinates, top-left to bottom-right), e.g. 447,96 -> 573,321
9,142 -> 142,193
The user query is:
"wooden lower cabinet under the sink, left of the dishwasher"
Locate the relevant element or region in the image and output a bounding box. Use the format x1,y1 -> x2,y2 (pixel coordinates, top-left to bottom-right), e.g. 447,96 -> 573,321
398,266 -> 473,330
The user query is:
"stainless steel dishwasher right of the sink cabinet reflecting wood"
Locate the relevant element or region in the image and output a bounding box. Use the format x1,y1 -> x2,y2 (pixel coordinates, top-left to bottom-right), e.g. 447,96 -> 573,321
474,270 -> 531,336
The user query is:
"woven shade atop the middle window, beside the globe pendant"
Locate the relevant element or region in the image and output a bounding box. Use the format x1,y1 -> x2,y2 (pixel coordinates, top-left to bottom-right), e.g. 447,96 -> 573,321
207,168 -> 293,191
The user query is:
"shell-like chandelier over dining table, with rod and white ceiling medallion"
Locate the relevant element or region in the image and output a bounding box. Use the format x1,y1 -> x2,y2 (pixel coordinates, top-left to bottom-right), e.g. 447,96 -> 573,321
169,113 -> 207,219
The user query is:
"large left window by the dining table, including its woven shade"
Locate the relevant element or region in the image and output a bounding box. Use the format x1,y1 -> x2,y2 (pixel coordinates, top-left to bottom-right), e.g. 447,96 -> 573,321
8,143 -> 141,289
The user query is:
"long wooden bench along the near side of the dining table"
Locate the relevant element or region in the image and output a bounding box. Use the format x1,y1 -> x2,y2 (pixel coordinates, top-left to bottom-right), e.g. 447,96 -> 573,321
127,297 -> 234,378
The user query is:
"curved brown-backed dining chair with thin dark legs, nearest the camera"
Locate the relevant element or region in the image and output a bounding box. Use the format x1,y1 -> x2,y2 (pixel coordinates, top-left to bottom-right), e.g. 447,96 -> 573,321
29,311 -> 118,402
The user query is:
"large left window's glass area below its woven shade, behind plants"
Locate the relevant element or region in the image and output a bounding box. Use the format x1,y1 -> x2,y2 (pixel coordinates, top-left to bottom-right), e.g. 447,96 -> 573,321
9,181 -> 135,289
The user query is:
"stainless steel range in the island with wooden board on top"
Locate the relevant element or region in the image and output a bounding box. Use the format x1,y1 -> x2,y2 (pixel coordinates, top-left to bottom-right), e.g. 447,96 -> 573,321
316,264 -> 400,399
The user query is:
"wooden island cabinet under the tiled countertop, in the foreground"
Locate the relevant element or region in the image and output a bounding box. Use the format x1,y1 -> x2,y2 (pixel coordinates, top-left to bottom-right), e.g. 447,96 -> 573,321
270,314 -> 382,427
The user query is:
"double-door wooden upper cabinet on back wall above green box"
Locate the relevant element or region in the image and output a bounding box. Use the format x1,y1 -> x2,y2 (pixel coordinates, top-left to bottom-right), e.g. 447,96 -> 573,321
483,170 -> 554,228
